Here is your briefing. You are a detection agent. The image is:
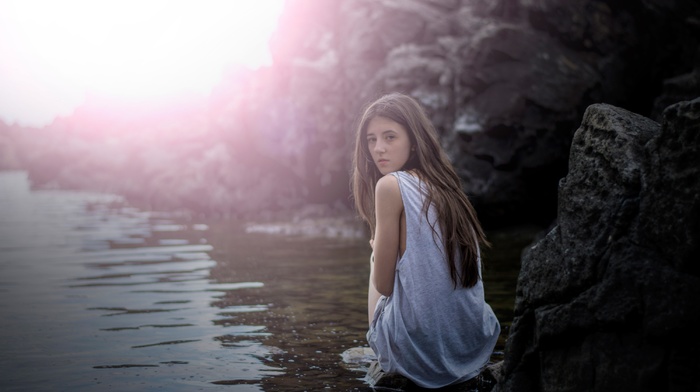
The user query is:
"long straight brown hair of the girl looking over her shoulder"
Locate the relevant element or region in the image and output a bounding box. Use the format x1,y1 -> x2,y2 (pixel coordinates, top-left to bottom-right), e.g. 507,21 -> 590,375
351,93 -> 489,287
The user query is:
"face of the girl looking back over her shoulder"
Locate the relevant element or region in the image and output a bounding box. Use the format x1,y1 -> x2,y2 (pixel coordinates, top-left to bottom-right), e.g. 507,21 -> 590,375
366,117 -> 411,175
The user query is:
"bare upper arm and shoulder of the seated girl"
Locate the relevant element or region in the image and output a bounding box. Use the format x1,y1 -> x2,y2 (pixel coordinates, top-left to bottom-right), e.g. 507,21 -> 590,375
373,175 -> 403,297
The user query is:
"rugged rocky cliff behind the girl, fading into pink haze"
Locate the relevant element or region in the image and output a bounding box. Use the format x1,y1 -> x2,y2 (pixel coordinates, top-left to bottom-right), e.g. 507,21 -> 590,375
2,0 -> 700,223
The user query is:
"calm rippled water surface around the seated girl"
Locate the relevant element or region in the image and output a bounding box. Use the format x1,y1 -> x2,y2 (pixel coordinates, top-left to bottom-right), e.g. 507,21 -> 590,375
0,172 -> 534,391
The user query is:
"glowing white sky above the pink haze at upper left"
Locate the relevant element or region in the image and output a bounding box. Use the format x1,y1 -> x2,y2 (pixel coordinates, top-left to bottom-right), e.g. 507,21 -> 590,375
0,0 -> 284,126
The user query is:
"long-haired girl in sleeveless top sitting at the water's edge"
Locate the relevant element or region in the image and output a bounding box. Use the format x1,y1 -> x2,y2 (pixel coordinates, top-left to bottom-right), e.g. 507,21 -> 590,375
352,93 -> 500,388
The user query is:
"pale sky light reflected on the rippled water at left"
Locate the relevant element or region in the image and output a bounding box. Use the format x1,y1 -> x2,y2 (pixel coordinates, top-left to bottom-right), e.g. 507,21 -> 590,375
0,172 -> 283,391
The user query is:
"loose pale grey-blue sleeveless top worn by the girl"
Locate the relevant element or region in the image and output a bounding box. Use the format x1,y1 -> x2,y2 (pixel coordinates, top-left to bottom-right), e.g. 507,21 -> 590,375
367,172 -> 501,388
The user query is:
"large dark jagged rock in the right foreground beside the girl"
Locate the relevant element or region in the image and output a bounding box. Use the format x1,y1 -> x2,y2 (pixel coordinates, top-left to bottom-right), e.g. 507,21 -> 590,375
497,98 -> 700,391
